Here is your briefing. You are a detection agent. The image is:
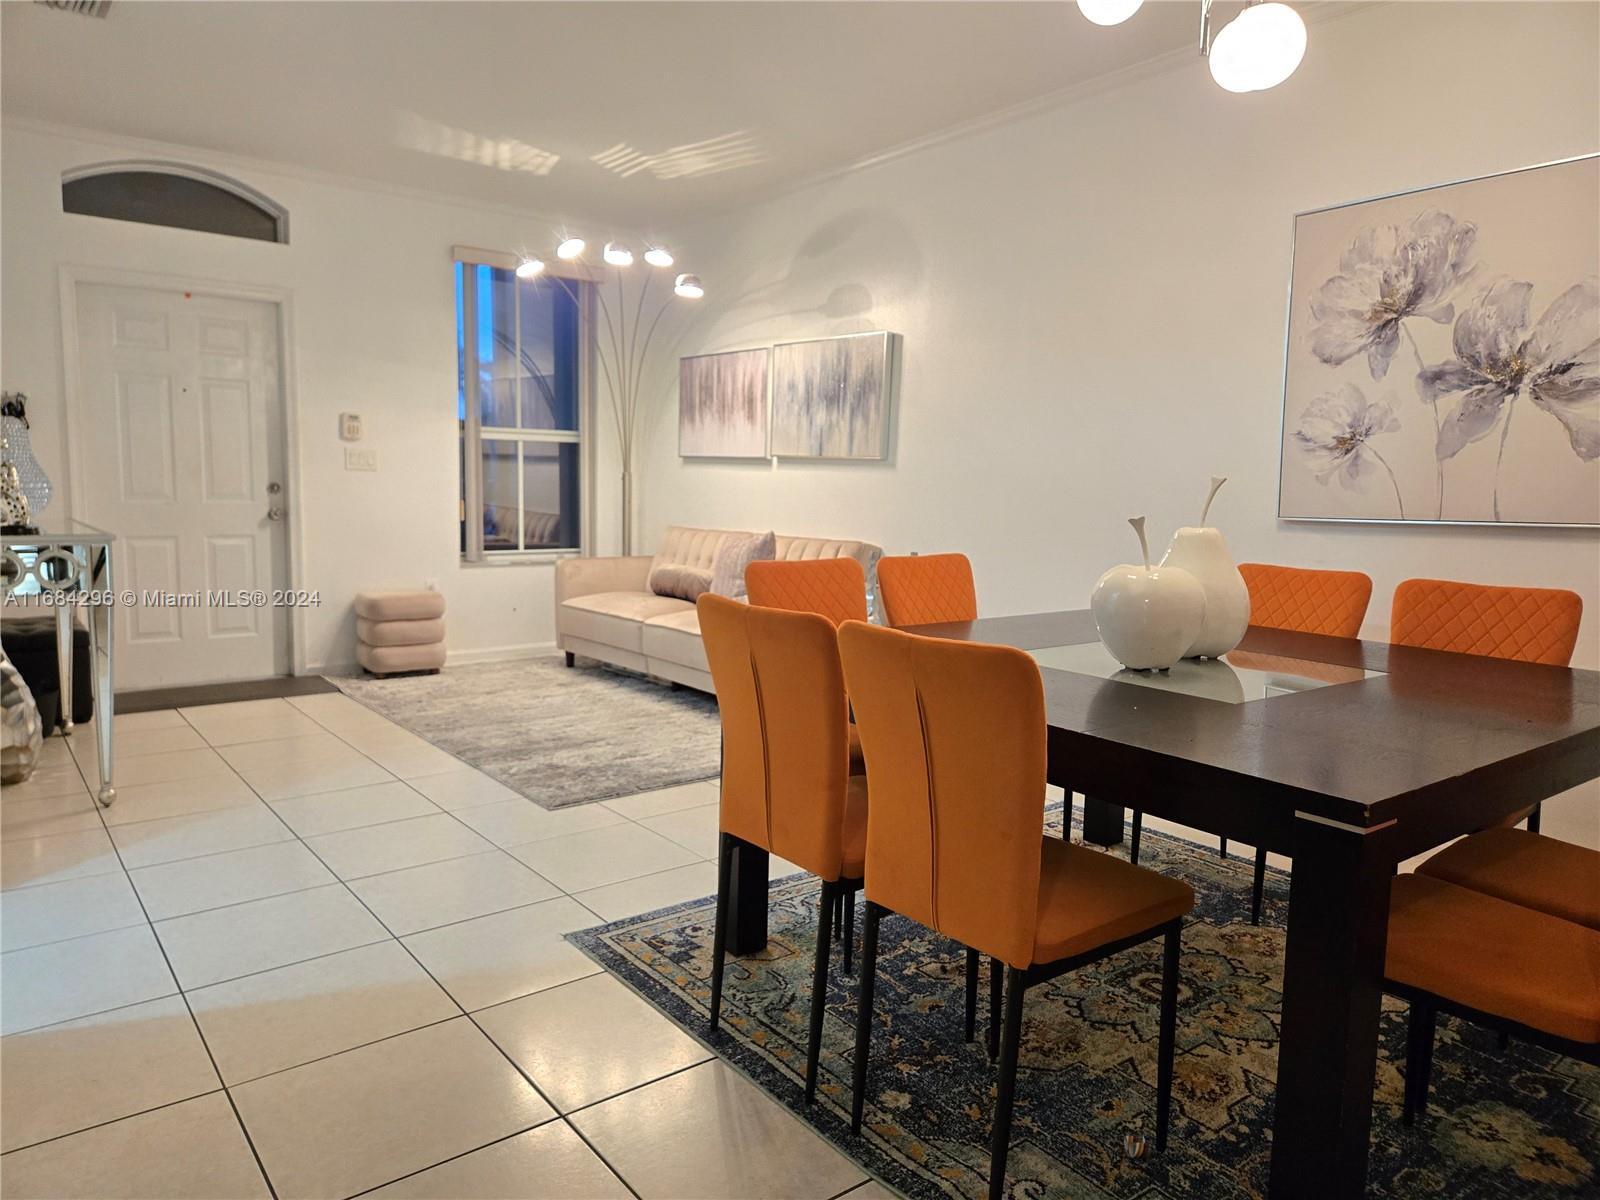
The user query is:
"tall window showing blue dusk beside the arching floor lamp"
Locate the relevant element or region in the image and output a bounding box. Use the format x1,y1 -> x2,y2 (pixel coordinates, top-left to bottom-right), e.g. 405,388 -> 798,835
456,262 -> 587,562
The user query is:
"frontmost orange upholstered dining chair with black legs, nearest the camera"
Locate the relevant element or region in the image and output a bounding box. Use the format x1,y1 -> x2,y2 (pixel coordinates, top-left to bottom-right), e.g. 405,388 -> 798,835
838,621 -> 1195,1197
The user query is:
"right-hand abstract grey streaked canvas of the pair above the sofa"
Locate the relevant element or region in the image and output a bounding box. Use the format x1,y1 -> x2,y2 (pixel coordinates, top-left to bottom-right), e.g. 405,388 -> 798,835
773,333 -> 899,459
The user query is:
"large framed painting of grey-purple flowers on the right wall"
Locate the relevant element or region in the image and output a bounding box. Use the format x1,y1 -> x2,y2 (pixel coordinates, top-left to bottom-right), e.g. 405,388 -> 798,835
1278,155 -> 1600,525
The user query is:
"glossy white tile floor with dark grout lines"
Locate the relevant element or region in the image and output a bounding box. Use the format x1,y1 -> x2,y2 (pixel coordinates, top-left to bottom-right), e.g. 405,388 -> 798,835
0,694 -> 888,1200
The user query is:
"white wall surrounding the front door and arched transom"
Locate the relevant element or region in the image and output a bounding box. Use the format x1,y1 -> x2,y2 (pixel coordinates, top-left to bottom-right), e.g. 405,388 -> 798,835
0,123 -> 618,686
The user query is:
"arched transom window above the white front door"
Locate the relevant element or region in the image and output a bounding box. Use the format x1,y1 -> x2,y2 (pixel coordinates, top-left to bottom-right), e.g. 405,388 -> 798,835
61,163 -> 290,242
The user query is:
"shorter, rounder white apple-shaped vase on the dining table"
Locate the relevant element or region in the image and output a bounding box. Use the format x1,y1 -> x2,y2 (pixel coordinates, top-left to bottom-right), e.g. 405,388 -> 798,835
1090,517 -> 1205,670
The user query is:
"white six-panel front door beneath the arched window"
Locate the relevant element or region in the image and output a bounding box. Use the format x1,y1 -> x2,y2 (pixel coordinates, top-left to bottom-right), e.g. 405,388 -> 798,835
72,283 -> 290,690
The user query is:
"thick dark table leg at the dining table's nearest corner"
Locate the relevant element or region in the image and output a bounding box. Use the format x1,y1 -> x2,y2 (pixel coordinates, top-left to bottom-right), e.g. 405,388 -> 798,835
1267,816 -> 1394,1200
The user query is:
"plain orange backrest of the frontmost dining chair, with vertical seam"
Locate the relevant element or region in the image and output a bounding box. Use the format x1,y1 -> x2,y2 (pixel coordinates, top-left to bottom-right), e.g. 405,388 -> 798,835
838,621 -> 1045,966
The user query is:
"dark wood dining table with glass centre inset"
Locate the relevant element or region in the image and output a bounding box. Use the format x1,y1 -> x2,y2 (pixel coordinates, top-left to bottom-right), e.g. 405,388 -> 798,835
730,611 -> 1600,1200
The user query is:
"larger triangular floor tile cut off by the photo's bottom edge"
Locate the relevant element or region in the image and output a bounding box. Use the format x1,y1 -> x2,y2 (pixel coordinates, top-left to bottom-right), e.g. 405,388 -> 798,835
368,1122 -> 634,1200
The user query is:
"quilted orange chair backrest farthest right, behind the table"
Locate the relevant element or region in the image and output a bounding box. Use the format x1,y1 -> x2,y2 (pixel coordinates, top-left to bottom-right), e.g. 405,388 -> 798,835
1389,579 -> 1584,667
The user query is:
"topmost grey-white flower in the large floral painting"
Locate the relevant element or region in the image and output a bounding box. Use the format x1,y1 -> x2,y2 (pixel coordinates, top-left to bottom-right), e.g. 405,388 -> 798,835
1310,210 -> 1478,379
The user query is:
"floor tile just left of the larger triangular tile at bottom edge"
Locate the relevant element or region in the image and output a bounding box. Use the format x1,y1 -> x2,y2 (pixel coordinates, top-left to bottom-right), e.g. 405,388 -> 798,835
234,1018 -> 550,1200
